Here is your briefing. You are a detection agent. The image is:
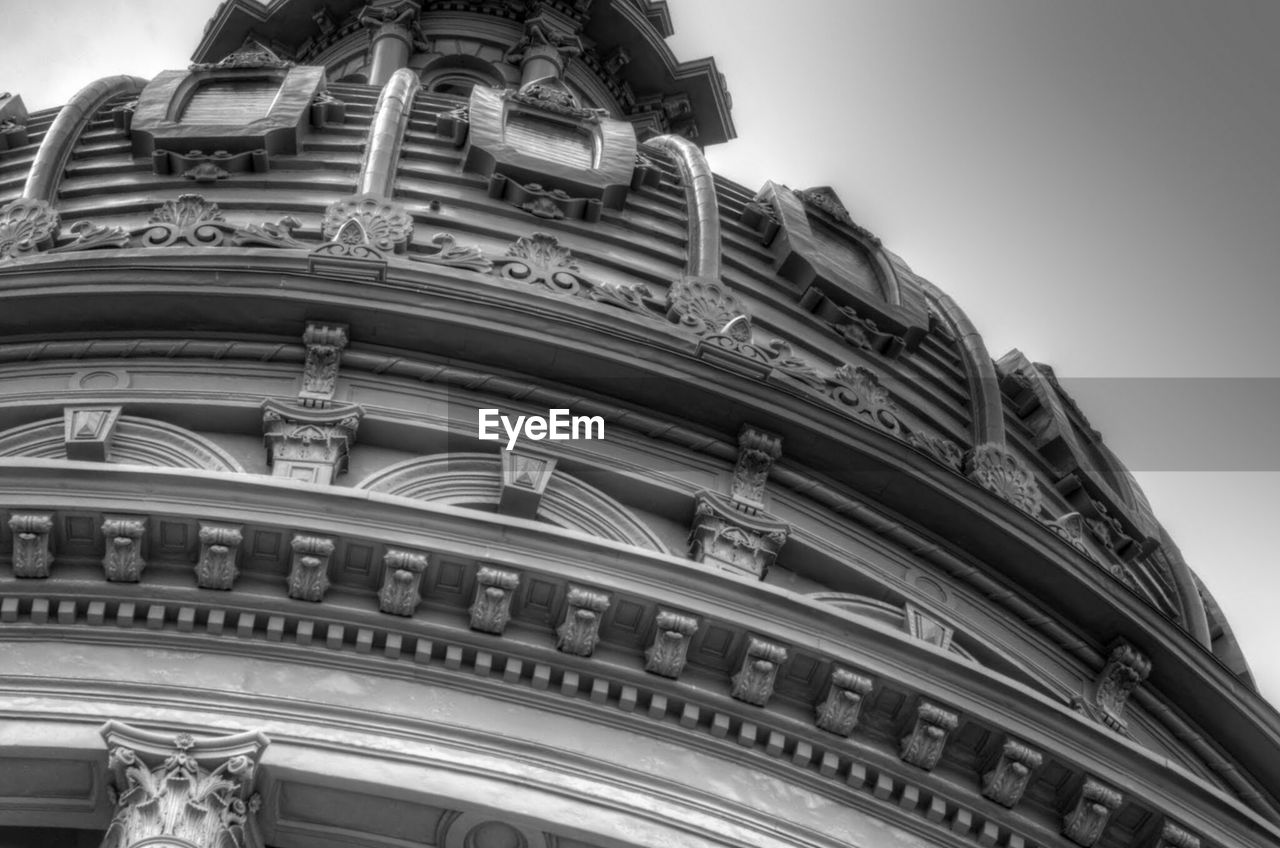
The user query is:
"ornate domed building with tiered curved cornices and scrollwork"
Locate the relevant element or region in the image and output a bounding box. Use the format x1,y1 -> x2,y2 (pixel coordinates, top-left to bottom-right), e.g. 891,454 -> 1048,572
0,0 -> 1280,848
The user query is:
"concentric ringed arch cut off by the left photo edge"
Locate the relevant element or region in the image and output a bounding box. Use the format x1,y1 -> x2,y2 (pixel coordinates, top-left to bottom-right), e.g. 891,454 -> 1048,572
0,415 -> 244,474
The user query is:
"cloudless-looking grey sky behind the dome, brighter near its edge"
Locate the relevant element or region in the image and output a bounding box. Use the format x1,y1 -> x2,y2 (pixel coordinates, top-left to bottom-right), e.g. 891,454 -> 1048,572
0,0 -> 1280,705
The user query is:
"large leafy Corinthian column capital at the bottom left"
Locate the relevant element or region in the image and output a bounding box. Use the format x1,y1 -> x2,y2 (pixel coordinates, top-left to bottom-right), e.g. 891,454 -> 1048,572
101,721 -> 268,848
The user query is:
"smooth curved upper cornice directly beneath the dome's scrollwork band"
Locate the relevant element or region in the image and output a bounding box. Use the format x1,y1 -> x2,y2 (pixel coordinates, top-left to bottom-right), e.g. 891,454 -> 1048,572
0,249 -> 1280,804
